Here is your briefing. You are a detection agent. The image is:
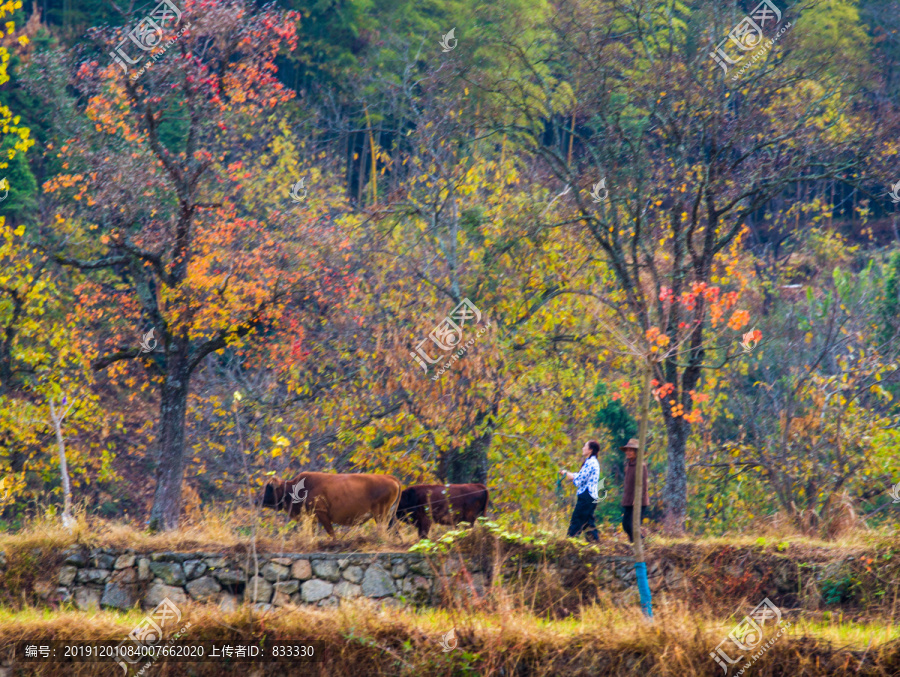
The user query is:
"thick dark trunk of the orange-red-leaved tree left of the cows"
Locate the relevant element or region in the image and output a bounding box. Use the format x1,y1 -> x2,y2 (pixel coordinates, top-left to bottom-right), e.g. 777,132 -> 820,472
150,352 -> 190,531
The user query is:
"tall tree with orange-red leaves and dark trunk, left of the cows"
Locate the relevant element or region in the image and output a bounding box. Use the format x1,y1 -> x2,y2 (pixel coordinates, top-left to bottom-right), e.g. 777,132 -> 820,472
35,1 -> 308,529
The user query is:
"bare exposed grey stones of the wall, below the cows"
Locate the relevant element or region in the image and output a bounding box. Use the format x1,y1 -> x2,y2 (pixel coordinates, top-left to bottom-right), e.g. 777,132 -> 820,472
56,548 -> 436,610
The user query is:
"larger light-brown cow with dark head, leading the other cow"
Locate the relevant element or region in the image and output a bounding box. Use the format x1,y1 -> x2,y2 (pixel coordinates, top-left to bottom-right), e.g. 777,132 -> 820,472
260,472 -> 402,538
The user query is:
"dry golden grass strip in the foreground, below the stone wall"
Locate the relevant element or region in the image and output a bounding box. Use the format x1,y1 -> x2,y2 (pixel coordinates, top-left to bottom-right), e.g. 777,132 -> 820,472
0,602 -> 900,677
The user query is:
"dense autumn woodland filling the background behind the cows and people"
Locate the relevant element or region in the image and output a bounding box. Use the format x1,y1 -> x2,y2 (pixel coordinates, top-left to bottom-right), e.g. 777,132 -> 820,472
0,0 -> 900,535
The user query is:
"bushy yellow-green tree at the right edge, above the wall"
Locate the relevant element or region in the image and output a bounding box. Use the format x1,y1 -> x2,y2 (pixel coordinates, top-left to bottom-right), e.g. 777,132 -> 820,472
712,248 -> 898,531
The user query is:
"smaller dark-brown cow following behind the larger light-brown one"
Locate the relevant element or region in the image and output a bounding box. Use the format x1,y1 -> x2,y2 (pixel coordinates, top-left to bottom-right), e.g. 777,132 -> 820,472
397,484 -> 488,538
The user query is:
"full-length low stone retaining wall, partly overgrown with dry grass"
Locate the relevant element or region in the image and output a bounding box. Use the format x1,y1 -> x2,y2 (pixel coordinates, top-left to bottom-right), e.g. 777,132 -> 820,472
0,546 -> 891,614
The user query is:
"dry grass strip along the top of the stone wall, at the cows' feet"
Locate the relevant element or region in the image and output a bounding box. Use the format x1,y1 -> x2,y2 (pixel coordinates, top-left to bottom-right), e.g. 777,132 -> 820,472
0,506 -> 898,555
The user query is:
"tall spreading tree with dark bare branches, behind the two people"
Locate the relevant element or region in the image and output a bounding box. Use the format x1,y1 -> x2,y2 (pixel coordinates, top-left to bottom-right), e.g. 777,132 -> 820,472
479,2 -> 892,532
